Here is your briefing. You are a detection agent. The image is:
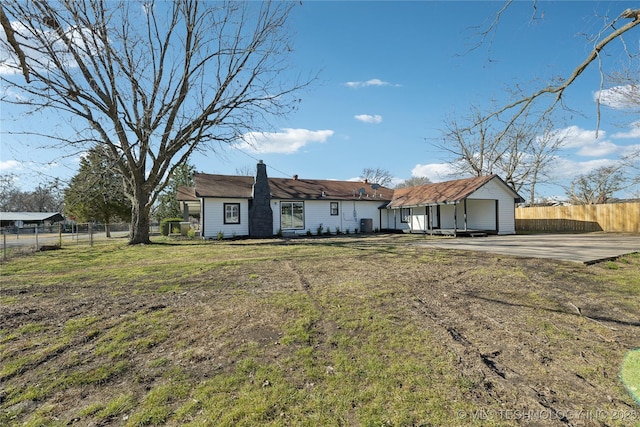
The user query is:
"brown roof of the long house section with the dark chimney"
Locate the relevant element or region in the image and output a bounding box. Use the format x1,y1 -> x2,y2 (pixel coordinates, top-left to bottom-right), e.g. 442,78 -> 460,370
188,173 -> 393,202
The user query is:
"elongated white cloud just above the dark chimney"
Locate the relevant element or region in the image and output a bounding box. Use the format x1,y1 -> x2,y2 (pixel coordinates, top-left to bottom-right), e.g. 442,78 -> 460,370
239,128 -> 334,154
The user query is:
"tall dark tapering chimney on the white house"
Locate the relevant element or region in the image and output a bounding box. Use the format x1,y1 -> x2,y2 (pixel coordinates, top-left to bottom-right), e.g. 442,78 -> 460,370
249,160 -> 273,237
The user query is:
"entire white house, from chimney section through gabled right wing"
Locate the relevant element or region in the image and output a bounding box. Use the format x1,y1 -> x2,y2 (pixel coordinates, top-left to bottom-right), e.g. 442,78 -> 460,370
178,161 -> 521,238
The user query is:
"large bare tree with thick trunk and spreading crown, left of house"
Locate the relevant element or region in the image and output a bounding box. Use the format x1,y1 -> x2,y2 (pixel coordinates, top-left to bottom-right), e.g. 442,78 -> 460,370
0,0 -> 312,243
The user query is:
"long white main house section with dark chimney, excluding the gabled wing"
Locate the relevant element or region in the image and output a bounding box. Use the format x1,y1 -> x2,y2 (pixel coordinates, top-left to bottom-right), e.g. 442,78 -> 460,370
178,161 -> 393,238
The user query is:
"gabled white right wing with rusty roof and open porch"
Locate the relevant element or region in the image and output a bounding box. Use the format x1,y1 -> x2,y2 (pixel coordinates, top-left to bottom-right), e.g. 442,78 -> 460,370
383,175 -> 524,235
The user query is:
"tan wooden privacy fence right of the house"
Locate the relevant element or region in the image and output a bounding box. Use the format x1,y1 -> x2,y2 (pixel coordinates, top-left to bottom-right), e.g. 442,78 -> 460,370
516,203 -> 640,233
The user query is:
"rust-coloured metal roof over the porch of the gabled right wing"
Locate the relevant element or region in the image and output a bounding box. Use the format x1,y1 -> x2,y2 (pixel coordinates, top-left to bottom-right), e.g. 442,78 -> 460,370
387,175 -> 502,208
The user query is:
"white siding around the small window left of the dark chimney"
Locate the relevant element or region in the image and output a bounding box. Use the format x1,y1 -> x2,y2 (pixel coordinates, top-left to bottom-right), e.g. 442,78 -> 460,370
202,198 -> 249,239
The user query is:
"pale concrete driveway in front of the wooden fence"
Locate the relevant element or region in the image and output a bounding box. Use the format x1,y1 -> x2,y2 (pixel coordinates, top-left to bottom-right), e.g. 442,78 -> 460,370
420,233 -> 640,264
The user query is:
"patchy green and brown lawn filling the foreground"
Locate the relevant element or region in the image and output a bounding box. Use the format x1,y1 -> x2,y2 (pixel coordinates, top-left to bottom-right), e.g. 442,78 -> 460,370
0,235 -> 640,426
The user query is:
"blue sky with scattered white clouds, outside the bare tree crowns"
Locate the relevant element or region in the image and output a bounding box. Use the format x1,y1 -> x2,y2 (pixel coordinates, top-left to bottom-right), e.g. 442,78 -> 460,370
0,1 -> 640,201
